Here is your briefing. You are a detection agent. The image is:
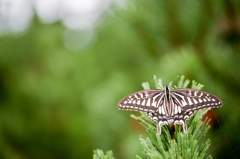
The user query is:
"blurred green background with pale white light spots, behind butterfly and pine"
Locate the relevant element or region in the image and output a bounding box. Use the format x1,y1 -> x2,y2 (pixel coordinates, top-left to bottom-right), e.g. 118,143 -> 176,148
0,0 -> 240,159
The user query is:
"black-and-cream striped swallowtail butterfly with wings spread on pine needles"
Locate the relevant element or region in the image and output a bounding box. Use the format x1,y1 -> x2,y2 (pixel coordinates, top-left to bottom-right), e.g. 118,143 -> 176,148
118,86 -> 223,135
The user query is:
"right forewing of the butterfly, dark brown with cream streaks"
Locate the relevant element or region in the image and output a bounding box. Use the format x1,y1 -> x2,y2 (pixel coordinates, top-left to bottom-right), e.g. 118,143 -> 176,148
171,89 -> 223,112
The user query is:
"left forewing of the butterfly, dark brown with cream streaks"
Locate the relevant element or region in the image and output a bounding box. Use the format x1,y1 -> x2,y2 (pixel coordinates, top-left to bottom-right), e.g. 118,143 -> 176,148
118,89 -> 164,113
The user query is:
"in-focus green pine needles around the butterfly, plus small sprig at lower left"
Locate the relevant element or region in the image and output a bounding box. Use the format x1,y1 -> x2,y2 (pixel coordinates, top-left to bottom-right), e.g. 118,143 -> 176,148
93,76 -> 211,159
